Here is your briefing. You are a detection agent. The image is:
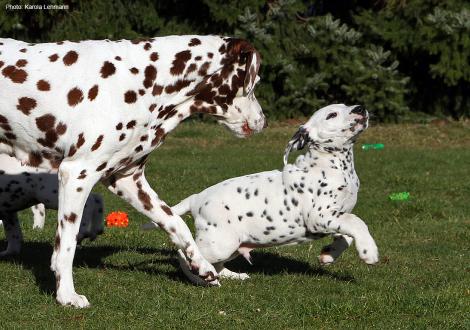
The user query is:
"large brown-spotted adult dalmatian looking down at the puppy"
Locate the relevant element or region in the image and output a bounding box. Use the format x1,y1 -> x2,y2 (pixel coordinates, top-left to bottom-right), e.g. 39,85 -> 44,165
0,36 -> 265,307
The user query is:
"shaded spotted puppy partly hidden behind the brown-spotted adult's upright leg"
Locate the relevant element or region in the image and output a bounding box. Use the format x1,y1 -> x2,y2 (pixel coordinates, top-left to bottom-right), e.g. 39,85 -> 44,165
0,154 -> 104,257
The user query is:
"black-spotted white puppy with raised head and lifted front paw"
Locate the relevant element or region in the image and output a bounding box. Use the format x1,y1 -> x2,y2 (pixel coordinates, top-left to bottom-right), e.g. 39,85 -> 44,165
144,104 -> 378,284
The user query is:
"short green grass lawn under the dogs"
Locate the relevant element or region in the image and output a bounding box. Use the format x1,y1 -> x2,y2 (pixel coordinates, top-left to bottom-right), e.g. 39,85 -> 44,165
0,123 -> 470,329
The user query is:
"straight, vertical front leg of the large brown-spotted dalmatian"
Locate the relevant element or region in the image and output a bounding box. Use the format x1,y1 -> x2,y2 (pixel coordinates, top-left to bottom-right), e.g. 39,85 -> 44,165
51,162 -> 99,308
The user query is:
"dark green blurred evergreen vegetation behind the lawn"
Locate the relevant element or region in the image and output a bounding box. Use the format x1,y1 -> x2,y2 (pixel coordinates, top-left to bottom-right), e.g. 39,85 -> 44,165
0,0 -> 470,122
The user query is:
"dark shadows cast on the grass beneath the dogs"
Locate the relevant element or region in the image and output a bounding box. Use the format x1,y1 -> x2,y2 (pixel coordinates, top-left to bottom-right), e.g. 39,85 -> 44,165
0,242 -> 355,294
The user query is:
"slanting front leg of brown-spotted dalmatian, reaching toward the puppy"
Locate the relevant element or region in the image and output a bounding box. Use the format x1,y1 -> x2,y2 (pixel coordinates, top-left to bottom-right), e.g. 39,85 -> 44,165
108,168 -> 217,282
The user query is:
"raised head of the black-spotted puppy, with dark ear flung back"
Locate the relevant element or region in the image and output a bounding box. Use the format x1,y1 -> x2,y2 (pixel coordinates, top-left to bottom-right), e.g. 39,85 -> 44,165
284,104 -> 369,164
